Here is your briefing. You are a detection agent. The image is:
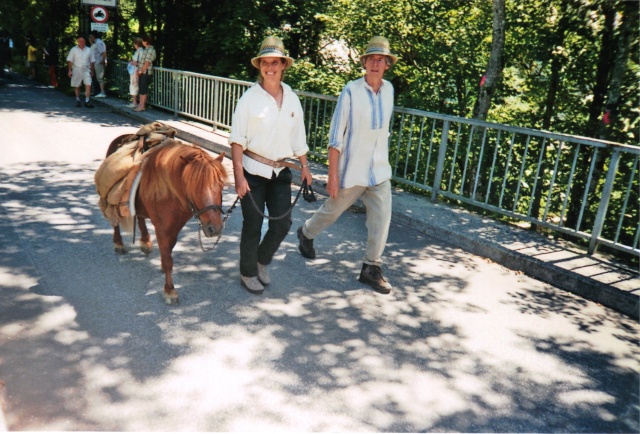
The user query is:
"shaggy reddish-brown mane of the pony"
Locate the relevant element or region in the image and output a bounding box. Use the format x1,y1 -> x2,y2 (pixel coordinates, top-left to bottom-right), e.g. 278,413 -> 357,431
142,141 -> 227,209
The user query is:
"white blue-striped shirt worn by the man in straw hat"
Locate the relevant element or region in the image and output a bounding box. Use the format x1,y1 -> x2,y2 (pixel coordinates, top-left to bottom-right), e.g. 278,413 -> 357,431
329,77 -> 394,188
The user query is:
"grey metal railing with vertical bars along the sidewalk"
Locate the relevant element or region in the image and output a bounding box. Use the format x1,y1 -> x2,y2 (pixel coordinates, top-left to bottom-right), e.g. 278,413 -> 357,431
111,62 -> 640,257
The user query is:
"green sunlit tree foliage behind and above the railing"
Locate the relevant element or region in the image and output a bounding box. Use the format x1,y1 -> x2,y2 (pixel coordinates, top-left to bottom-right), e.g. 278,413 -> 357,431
0,0 -> 640,145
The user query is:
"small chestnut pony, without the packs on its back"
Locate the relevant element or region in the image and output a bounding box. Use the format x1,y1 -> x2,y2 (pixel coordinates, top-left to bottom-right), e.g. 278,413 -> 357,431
107,135 -> 227,304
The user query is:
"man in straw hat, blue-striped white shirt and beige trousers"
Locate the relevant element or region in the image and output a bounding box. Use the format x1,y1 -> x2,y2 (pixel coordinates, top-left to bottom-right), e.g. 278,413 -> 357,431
298,36 -> 398,294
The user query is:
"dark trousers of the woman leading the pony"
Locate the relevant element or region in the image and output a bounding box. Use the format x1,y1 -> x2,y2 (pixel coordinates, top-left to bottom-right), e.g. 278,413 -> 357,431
240,168 -> 292,277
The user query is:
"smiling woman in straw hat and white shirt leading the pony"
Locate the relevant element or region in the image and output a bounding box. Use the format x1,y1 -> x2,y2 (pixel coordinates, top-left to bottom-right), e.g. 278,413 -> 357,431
229,36 -> 312,294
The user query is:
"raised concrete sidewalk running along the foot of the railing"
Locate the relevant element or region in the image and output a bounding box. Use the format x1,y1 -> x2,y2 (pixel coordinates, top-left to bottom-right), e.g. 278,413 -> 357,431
93,97 -> 640,320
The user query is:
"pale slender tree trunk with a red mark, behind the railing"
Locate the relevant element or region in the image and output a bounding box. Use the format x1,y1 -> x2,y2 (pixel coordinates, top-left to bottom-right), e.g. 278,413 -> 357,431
473,0 -> 505,120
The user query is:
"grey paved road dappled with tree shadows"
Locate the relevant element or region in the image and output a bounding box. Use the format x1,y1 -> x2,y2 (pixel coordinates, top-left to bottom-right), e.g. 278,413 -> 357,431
0,77 -> 640,432
